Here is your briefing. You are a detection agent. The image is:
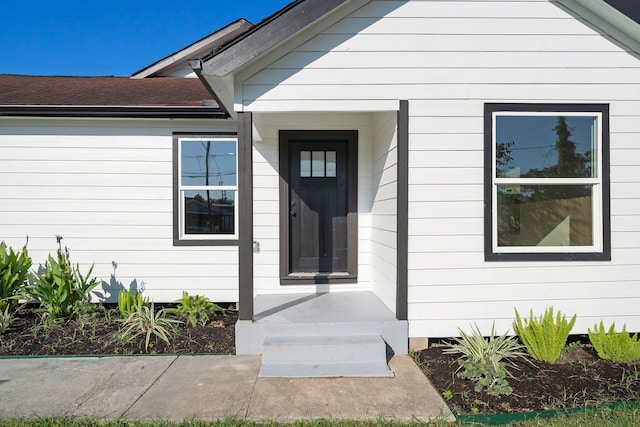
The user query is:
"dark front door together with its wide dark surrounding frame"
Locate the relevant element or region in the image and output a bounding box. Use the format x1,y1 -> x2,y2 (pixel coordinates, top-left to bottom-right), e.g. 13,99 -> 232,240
280,131 -> 357,283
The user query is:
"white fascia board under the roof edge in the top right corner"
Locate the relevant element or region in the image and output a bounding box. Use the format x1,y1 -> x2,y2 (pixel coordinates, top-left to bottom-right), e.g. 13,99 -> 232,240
550,0 -> 640,54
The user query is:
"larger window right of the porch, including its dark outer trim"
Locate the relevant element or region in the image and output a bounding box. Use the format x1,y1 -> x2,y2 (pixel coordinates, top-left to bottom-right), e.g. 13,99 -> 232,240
485,104 -> 611,261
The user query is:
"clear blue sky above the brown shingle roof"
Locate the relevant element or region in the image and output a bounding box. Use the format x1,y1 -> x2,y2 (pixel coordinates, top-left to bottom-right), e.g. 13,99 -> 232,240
0,0 -> 291,76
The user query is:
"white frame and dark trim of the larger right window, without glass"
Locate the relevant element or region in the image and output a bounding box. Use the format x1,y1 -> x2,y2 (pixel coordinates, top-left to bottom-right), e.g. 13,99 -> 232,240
485,104 -> 611,261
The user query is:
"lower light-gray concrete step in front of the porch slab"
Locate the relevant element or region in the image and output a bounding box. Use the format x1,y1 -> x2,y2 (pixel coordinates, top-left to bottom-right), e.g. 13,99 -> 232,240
260,335 -> 393,378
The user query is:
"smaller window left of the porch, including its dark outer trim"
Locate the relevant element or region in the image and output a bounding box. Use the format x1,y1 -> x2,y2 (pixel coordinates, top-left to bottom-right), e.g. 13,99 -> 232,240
174,135 -> 238,244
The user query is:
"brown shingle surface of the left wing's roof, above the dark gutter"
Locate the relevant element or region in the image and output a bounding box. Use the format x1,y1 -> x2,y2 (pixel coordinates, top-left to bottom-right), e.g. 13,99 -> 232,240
0,74 -> 215,107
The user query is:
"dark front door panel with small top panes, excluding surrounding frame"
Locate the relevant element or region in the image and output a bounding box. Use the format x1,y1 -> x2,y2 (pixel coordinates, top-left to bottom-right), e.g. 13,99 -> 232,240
289,141 -> 349,274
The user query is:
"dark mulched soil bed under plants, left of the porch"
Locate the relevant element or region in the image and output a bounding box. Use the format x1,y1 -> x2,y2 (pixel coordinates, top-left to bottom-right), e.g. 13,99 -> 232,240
0,307 -> 238,356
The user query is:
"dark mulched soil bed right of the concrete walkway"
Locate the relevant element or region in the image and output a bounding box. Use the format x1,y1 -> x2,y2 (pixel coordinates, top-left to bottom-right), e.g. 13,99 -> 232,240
416,344 -> 640,414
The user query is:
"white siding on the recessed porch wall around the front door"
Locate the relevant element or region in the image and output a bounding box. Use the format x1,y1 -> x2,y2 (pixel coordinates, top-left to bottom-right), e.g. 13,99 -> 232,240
253,113 -> 374,294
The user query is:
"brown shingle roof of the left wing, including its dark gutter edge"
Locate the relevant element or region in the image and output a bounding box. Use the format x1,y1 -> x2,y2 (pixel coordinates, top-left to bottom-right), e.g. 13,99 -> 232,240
0,74 -> 224,118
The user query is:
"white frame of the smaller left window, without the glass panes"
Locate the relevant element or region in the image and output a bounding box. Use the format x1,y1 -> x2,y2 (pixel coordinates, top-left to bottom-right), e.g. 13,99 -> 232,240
176,135 -> 240,241
